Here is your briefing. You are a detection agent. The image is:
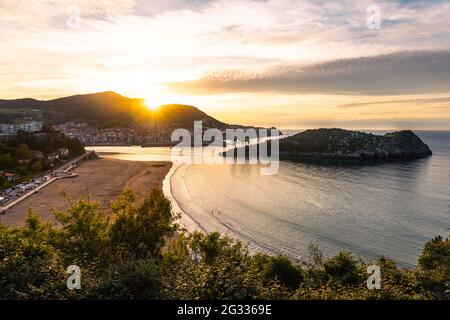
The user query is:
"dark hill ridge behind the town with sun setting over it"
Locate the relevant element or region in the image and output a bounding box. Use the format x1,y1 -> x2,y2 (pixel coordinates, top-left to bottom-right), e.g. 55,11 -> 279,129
0,91 -> 228,128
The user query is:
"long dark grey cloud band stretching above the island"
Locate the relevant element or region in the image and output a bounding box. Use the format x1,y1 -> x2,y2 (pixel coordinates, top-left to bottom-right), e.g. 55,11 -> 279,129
168,51 -> 450,95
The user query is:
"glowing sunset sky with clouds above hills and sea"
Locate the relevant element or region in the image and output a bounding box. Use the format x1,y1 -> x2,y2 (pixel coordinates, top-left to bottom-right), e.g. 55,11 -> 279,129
0,0 -> 450,129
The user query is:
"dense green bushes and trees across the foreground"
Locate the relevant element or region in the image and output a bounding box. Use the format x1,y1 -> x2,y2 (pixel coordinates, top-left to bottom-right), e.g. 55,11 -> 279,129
0,190 -> 450,299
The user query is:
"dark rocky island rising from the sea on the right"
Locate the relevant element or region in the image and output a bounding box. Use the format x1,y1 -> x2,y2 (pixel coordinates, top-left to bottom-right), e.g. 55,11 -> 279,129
224,128 -> 432,160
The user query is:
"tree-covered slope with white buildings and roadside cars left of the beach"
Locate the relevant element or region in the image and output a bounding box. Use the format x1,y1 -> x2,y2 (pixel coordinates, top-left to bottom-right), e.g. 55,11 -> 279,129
0,121 -> 86,213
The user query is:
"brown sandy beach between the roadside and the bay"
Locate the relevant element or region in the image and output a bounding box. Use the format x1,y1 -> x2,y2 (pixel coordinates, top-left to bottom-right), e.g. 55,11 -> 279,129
0,158 -> 172,226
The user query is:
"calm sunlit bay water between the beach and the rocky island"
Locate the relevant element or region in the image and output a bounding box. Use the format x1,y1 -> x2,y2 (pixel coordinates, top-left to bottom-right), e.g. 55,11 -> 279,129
86,132 -> 450,267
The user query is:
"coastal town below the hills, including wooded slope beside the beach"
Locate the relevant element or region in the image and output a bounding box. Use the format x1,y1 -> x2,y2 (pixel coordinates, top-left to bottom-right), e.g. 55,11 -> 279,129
0,118 -> 203,210
